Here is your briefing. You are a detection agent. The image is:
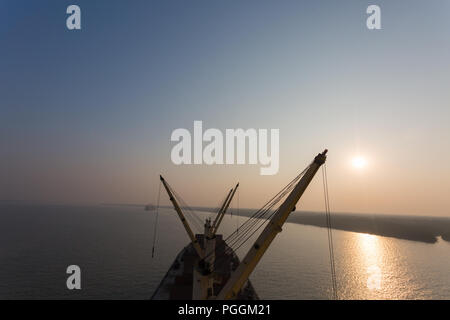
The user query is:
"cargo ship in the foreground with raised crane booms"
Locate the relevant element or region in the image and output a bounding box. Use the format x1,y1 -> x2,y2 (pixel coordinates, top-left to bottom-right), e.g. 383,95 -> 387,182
151,150 -> 327,300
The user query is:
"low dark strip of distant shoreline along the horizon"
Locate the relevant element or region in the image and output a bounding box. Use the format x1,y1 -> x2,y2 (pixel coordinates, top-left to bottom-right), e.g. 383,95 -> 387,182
178,207 -> 450,243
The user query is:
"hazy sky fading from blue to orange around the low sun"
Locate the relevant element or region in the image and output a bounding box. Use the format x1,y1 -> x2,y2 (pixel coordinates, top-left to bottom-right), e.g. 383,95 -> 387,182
0,0 -> 450,216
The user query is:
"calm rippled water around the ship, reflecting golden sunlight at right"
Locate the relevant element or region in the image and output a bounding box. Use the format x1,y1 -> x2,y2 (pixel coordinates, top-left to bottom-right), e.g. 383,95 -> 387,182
0,205 -> 450,299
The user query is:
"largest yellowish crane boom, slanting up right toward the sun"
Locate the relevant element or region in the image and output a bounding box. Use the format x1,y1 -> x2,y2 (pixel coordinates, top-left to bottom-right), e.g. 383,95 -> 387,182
216,150 -> 328,300
